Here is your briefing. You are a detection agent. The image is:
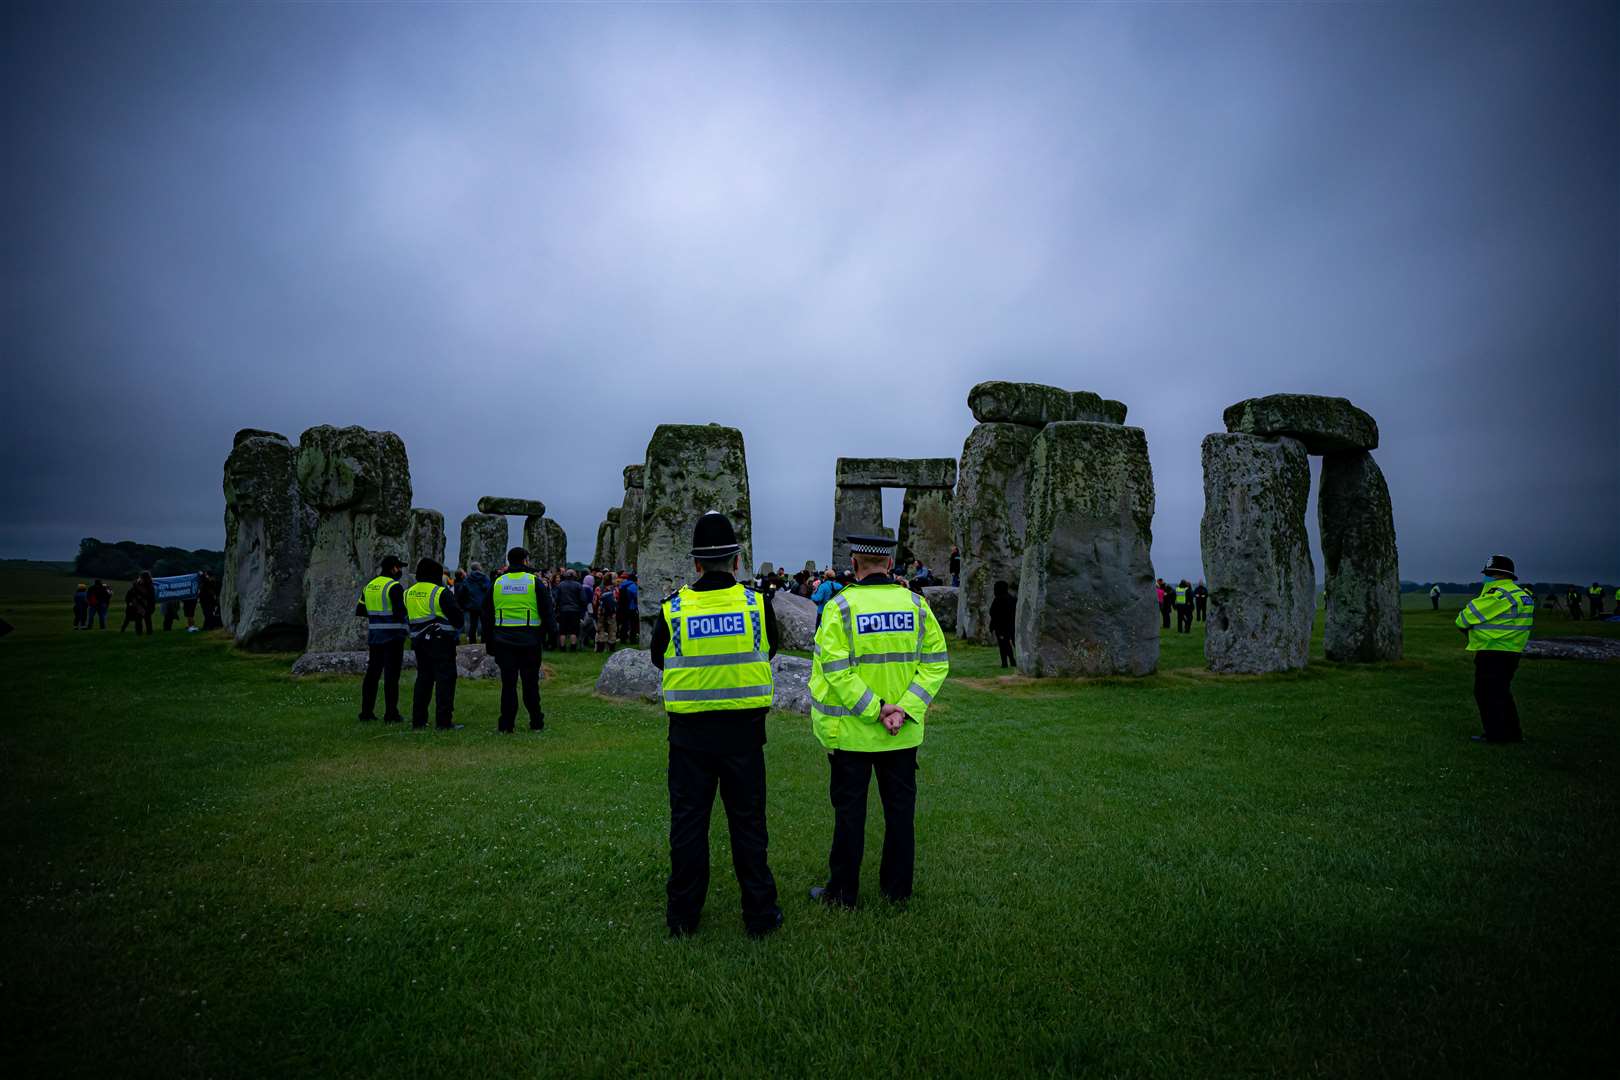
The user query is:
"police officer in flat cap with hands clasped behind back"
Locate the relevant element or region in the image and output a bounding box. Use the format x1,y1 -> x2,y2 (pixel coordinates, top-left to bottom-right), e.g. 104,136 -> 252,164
810,536 -> 951,907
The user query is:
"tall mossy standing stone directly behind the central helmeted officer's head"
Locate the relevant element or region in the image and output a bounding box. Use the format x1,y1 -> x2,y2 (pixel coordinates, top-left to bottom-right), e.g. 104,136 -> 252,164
637,424 -> 753,633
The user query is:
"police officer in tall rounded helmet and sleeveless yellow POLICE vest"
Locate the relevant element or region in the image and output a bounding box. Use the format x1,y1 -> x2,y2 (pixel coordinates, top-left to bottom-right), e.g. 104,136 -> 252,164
651,512 -> 782,938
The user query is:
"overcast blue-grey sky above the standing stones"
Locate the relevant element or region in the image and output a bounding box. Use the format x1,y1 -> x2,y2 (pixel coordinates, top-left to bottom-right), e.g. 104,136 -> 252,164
0,3 -> 1620,580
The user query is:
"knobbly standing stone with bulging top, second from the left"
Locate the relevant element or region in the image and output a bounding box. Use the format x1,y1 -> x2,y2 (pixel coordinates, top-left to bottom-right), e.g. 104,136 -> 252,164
298,424 -> 411,653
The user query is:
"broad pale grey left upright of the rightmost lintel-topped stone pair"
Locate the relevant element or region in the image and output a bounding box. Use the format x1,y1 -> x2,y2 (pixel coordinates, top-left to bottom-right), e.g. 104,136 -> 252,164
1205,434 -> 1315,674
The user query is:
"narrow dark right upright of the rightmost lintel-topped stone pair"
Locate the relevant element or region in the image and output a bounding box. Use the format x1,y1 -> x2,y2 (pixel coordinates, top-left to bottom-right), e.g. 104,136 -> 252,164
1317,450 -> 1401,662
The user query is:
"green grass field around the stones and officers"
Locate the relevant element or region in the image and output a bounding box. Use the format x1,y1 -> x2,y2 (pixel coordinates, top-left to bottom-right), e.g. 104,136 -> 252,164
0,570 -> 1620,1077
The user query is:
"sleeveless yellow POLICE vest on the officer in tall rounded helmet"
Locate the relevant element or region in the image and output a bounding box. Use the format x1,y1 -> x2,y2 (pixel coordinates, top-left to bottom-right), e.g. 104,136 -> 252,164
659,585 -> 773,712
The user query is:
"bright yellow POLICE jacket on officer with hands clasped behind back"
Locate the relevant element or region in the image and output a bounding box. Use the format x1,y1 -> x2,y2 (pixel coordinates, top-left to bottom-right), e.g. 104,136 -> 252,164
810,581 -> 951,751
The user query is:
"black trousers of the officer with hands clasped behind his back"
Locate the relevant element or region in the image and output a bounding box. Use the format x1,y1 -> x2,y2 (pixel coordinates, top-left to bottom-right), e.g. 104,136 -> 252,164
826,746 -> 917,905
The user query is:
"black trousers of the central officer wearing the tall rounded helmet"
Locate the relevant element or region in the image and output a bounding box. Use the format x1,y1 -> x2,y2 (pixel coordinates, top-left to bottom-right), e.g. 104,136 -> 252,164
664,743 -> 782,931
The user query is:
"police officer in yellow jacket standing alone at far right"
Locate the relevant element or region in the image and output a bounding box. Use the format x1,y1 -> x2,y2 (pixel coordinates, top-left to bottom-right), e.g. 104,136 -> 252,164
1456,555 -> 1536,743
